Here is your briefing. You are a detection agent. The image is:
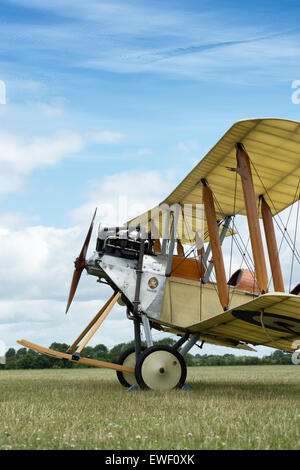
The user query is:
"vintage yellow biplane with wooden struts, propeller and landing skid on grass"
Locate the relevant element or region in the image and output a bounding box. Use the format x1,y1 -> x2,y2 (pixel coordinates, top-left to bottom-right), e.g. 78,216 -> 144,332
19,118 -> 300,390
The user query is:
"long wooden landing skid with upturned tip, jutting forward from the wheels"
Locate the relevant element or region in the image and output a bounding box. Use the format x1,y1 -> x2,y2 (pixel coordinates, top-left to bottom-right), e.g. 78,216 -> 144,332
18,339 -> 134,374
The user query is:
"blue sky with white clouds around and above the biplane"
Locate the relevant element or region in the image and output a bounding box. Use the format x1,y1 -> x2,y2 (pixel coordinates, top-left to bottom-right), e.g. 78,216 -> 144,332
0,0 -> 300,355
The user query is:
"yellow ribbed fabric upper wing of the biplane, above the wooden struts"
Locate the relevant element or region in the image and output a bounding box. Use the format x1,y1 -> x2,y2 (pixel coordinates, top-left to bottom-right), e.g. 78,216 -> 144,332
128,118 -> 300,237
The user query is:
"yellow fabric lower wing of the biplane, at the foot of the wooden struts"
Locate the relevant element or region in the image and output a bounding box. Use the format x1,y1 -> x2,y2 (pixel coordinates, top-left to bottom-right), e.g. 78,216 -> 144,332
188,293 -> 300,352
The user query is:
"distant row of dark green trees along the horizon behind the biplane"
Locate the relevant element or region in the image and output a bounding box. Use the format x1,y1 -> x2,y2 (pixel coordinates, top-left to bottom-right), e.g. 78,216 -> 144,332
0,338 -> 292,369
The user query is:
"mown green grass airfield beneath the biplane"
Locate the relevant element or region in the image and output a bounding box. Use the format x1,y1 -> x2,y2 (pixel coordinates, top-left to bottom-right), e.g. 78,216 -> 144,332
0,365 -> 300,450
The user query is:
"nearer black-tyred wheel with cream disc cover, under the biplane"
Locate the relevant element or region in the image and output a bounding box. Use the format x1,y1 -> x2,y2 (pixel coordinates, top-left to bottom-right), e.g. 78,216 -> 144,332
135,345 -> 186,390
